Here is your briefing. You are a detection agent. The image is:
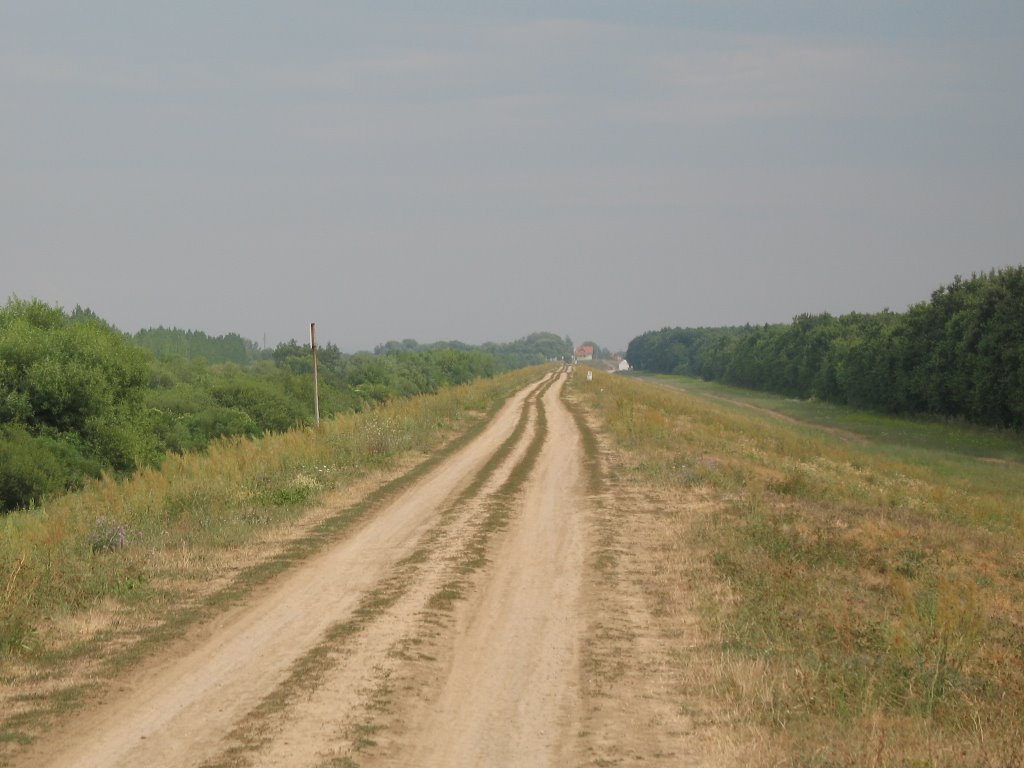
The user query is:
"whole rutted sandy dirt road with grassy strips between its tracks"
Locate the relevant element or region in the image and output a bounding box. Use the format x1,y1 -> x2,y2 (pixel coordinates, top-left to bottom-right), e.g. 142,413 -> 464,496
16,371 -> 704,768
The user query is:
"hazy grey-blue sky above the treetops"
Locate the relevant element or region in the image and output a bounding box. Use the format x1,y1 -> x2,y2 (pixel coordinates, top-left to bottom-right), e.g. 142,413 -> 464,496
0,0 -> 1024,350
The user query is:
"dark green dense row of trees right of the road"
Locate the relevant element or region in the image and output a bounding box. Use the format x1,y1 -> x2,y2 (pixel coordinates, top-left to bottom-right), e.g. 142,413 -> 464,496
627,266 -> 1024,430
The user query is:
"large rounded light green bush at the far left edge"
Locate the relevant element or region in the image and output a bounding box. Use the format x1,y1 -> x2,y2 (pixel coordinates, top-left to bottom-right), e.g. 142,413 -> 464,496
0,298 -> 160,509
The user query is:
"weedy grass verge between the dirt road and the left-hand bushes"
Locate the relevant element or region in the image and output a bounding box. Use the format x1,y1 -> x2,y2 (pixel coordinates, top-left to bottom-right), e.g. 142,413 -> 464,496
0,369 -> 540,753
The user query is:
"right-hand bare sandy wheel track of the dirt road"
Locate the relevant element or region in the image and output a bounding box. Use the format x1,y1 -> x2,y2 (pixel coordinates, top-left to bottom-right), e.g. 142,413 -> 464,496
391,370 -> 585,768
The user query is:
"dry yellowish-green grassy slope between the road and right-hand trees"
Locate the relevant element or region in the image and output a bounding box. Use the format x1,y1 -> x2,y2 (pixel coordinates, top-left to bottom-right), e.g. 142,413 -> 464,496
577,373 -> 1024,766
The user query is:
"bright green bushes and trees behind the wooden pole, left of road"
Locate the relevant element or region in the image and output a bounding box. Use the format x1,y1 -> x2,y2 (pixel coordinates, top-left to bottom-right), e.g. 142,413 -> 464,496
0,298 -> 572,511
